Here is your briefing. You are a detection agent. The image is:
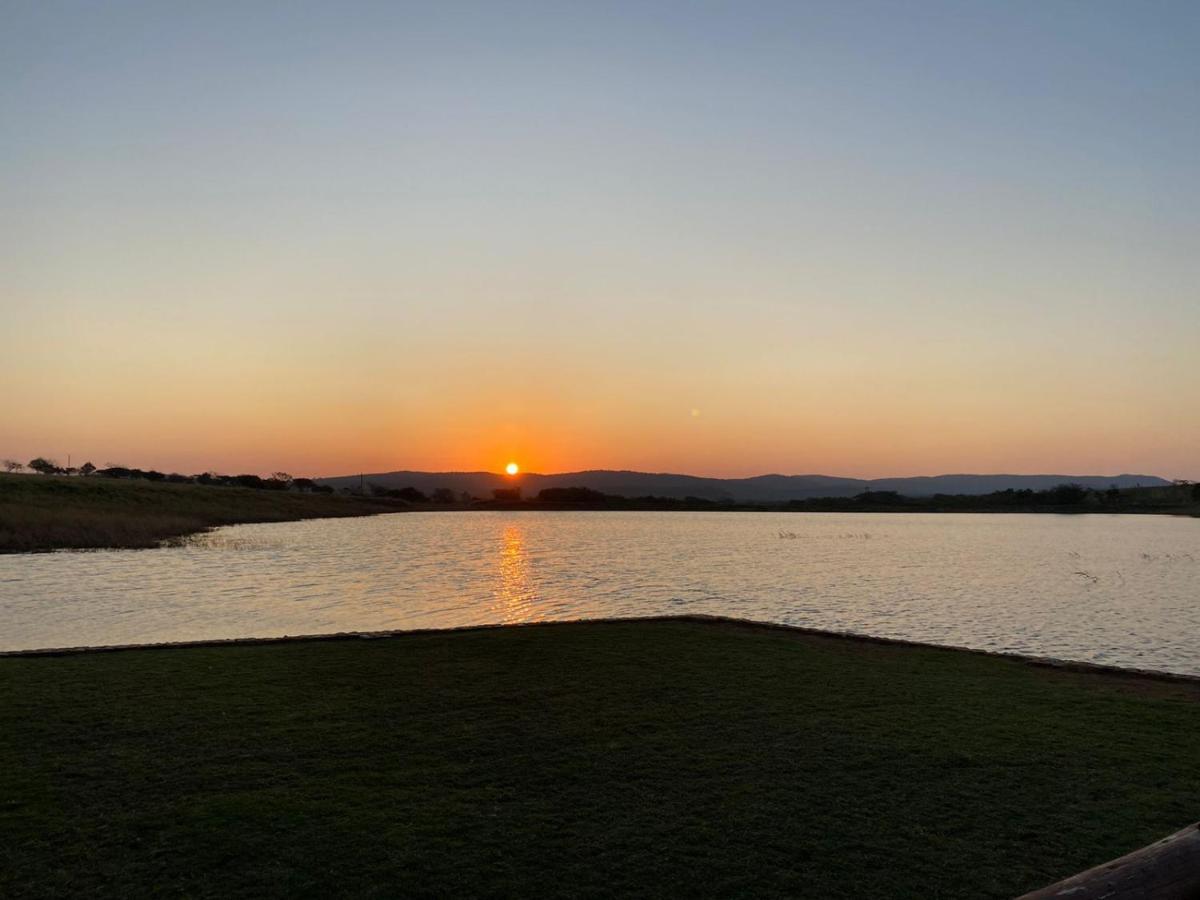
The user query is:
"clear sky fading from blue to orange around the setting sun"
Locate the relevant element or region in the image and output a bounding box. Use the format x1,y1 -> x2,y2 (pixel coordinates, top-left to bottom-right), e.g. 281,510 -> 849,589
0,0 -> 1200,479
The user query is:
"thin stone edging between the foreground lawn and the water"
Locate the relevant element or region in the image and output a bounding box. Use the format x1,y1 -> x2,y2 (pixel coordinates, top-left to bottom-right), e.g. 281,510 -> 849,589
0,613 -> 1200,686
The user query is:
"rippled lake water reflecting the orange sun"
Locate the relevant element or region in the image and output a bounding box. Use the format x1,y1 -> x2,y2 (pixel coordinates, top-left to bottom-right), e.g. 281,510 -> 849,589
0,512 -> 1200,673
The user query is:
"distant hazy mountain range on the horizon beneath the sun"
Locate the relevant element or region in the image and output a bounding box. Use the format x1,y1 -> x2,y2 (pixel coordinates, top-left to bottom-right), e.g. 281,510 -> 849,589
318,469 -> 1170,503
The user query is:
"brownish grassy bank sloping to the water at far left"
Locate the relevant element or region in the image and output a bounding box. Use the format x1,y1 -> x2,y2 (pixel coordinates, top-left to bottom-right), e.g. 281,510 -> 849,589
0,475 -> 403,553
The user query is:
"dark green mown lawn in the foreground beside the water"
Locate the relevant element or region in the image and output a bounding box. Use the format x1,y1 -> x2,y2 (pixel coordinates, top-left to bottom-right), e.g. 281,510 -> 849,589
0,620 -> 1200,898
